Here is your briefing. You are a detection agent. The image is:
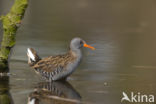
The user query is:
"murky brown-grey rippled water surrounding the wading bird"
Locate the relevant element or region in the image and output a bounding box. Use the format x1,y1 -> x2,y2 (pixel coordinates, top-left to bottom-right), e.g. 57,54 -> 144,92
0,0 -> 156,104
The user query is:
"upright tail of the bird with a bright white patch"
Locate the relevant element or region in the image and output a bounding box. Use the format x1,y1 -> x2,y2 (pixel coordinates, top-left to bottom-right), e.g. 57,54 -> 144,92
27,48 -> 41,66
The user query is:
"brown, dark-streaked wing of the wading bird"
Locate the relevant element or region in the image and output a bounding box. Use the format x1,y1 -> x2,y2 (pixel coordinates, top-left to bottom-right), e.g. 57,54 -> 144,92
33,52 -> 75,72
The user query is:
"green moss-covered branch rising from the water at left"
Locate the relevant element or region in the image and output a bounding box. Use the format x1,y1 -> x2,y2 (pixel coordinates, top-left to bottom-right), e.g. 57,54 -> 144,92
0,0 -> 28,73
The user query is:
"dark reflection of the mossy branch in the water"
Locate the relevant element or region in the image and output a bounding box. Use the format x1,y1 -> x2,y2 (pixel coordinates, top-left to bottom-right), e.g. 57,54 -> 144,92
0,76 -> 13,104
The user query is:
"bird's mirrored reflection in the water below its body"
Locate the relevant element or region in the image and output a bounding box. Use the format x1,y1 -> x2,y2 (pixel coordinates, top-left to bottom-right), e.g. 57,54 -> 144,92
28,82 -> 81,104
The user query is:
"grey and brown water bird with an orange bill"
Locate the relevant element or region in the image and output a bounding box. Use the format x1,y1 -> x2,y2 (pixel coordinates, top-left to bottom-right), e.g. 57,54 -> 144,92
27,37 -> 95,81
